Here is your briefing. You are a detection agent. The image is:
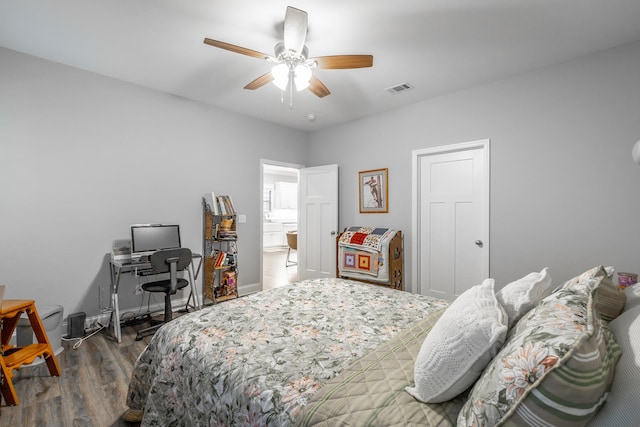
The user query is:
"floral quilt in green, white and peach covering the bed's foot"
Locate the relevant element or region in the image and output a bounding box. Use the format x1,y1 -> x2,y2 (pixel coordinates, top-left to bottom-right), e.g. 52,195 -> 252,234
127,279 -> 448,426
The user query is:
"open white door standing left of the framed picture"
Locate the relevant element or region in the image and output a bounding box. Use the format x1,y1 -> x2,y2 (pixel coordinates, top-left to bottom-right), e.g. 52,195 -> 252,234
298,165 -> 338,280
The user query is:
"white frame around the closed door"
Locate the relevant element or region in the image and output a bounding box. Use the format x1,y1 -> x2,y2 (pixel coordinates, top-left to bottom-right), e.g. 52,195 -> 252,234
411,139 -> 491,294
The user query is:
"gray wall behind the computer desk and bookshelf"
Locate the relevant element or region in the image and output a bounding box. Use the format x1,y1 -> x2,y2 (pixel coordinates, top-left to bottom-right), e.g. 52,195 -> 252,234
0,48 -> 308,316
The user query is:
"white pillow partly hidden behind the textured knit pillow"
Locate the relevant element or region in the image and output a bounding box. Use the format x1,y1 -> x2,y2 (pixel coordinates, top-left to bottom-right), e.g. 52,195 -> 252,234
496,267 -> 551,329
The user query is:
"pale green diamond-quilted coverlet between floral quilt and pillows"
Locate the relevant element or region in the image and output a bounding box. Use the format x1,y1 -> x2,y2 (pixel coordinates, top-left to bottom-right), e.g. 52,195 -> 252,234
296,311 -> 464,427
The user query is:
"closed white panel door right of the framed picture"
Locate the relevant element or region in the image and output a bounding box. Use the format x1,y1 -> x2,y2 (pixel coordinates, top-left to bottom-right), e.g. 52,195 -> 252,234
412,140 -> 489,300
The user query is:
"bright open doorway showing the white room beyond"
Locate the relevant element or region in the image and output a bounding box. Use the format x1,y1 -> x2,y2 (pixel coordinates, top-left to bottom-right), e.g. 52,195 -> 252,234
260,160 -> 302,290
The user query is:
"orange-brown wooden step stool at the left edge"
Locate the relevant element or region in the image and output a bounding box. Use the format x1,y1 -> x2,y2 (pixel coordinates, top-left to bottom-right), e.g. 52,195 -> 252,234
0,300 -> 60,406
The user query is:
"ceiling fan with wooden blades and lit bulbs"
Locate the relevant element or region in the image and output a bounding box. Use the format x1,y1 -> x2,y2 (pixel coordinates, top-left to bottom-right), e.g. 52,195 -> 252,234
204,6 -> 373,107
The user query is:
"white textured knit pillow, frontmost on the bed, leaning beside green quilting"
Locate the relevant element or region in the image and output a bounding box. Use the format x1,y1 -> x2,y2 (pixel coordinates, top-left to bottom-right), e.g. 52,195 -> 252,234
406,279 -> 507,403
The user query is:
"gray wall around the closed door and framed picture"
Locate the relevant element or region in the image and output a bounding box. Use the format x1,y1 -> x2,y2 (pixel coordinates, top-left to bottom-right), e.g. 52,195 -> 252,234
310,43 -> 640,287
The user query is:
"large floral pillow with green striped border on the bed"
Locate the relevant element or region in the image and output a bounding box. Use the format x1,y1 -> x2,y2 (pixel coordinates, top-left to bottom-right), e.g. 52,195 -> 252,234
458,278 -> 621,426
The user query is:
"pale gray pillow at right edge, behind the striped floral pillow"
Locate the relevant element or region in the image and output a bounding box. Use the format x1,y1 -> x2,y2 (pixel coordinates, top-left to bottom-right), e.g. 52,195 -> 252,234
589,306 -> 640,427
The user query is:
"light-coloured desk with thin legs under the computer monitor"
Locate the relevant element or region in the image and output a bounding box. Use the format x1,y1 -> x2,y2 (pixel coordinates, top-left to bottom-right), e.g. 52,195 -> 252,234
109,253 -> 202,342
